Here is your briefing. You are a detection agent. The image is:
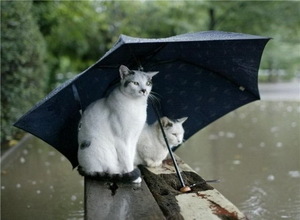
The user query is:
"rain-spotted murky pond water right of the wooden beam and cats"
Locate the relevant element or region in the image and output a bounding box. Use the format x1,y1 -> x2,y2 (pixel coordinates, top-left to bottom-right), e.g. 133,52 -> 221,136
176,101 -> 300,220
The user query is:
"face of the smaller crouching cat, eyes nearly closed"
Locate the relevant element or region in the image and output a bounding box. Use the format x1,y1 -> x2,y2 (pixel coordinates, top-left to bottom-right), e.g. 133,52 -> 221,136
161,117 -> 187,146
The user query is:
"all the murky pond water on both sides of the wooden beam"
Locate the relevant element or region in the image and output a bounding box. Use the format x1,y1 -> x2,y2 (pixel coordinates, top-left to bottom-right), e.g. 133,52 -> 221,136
1,84 -> 300,220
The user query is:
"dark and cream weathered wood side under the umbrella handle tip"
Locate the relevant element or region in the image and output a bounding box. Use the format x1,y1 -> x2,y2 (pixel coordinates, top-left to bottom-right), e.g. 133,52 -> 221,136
140,157 -> 247,220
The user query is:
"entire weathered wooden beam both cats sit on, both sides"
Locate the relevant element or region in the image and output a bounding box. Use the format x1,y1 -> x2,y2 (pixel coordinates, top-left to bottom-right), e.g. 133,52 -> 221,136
85,157 -> 247,220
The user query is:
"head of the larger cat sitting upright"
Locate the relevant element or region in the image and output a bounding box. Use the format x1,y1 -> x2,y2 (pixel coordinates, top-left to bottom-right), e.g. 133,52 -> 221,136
119,65 -> 158,98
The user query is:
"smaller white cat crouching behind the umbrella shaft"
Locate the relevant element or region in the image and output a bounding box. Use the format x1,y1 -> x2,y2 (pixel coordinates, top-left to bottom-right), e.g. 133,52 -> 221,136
135,117 -> 187,167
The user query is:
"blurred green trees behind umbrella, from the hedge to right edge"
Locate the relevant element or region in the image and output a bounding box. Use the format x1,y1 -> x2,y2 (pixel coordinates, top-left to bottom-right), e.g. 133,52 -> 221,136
34,1 -> 300,90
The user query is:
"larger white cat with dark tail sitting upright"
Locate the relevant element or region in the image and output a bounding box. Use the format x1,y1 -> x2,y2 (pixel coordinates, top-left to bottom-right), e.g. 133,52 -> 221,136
78,65 -> 158,183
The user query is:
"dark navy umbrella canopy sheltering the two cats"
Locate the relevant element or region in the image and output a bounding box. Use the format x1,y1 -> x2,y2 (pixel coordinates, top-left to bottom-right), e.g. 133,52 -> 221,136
15,31 -> 270,167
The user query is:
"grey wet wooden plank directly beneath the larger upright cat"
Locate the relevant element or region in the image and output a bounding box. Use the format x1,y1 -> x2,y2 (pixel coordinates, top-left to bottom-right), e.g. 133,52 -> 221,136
85,179 -> 165,220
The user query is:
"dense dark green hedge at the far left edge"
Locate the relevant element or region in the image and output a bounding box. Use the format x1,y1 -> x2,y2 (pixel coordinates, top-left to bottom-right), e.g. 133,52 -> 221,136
1,1 -> 47,142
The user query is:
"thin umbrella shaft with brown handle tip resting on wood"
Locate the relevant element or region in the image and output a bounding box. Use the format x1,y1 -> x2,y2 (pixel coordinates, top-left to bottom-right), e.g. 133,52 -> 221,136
152,103 -> 191,192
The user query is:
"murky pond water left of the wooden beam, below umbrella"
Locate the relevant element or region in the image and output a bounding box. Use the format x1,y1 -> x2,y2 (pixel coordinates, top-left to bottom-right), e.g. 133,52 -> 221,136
1,137 -> 84,220
